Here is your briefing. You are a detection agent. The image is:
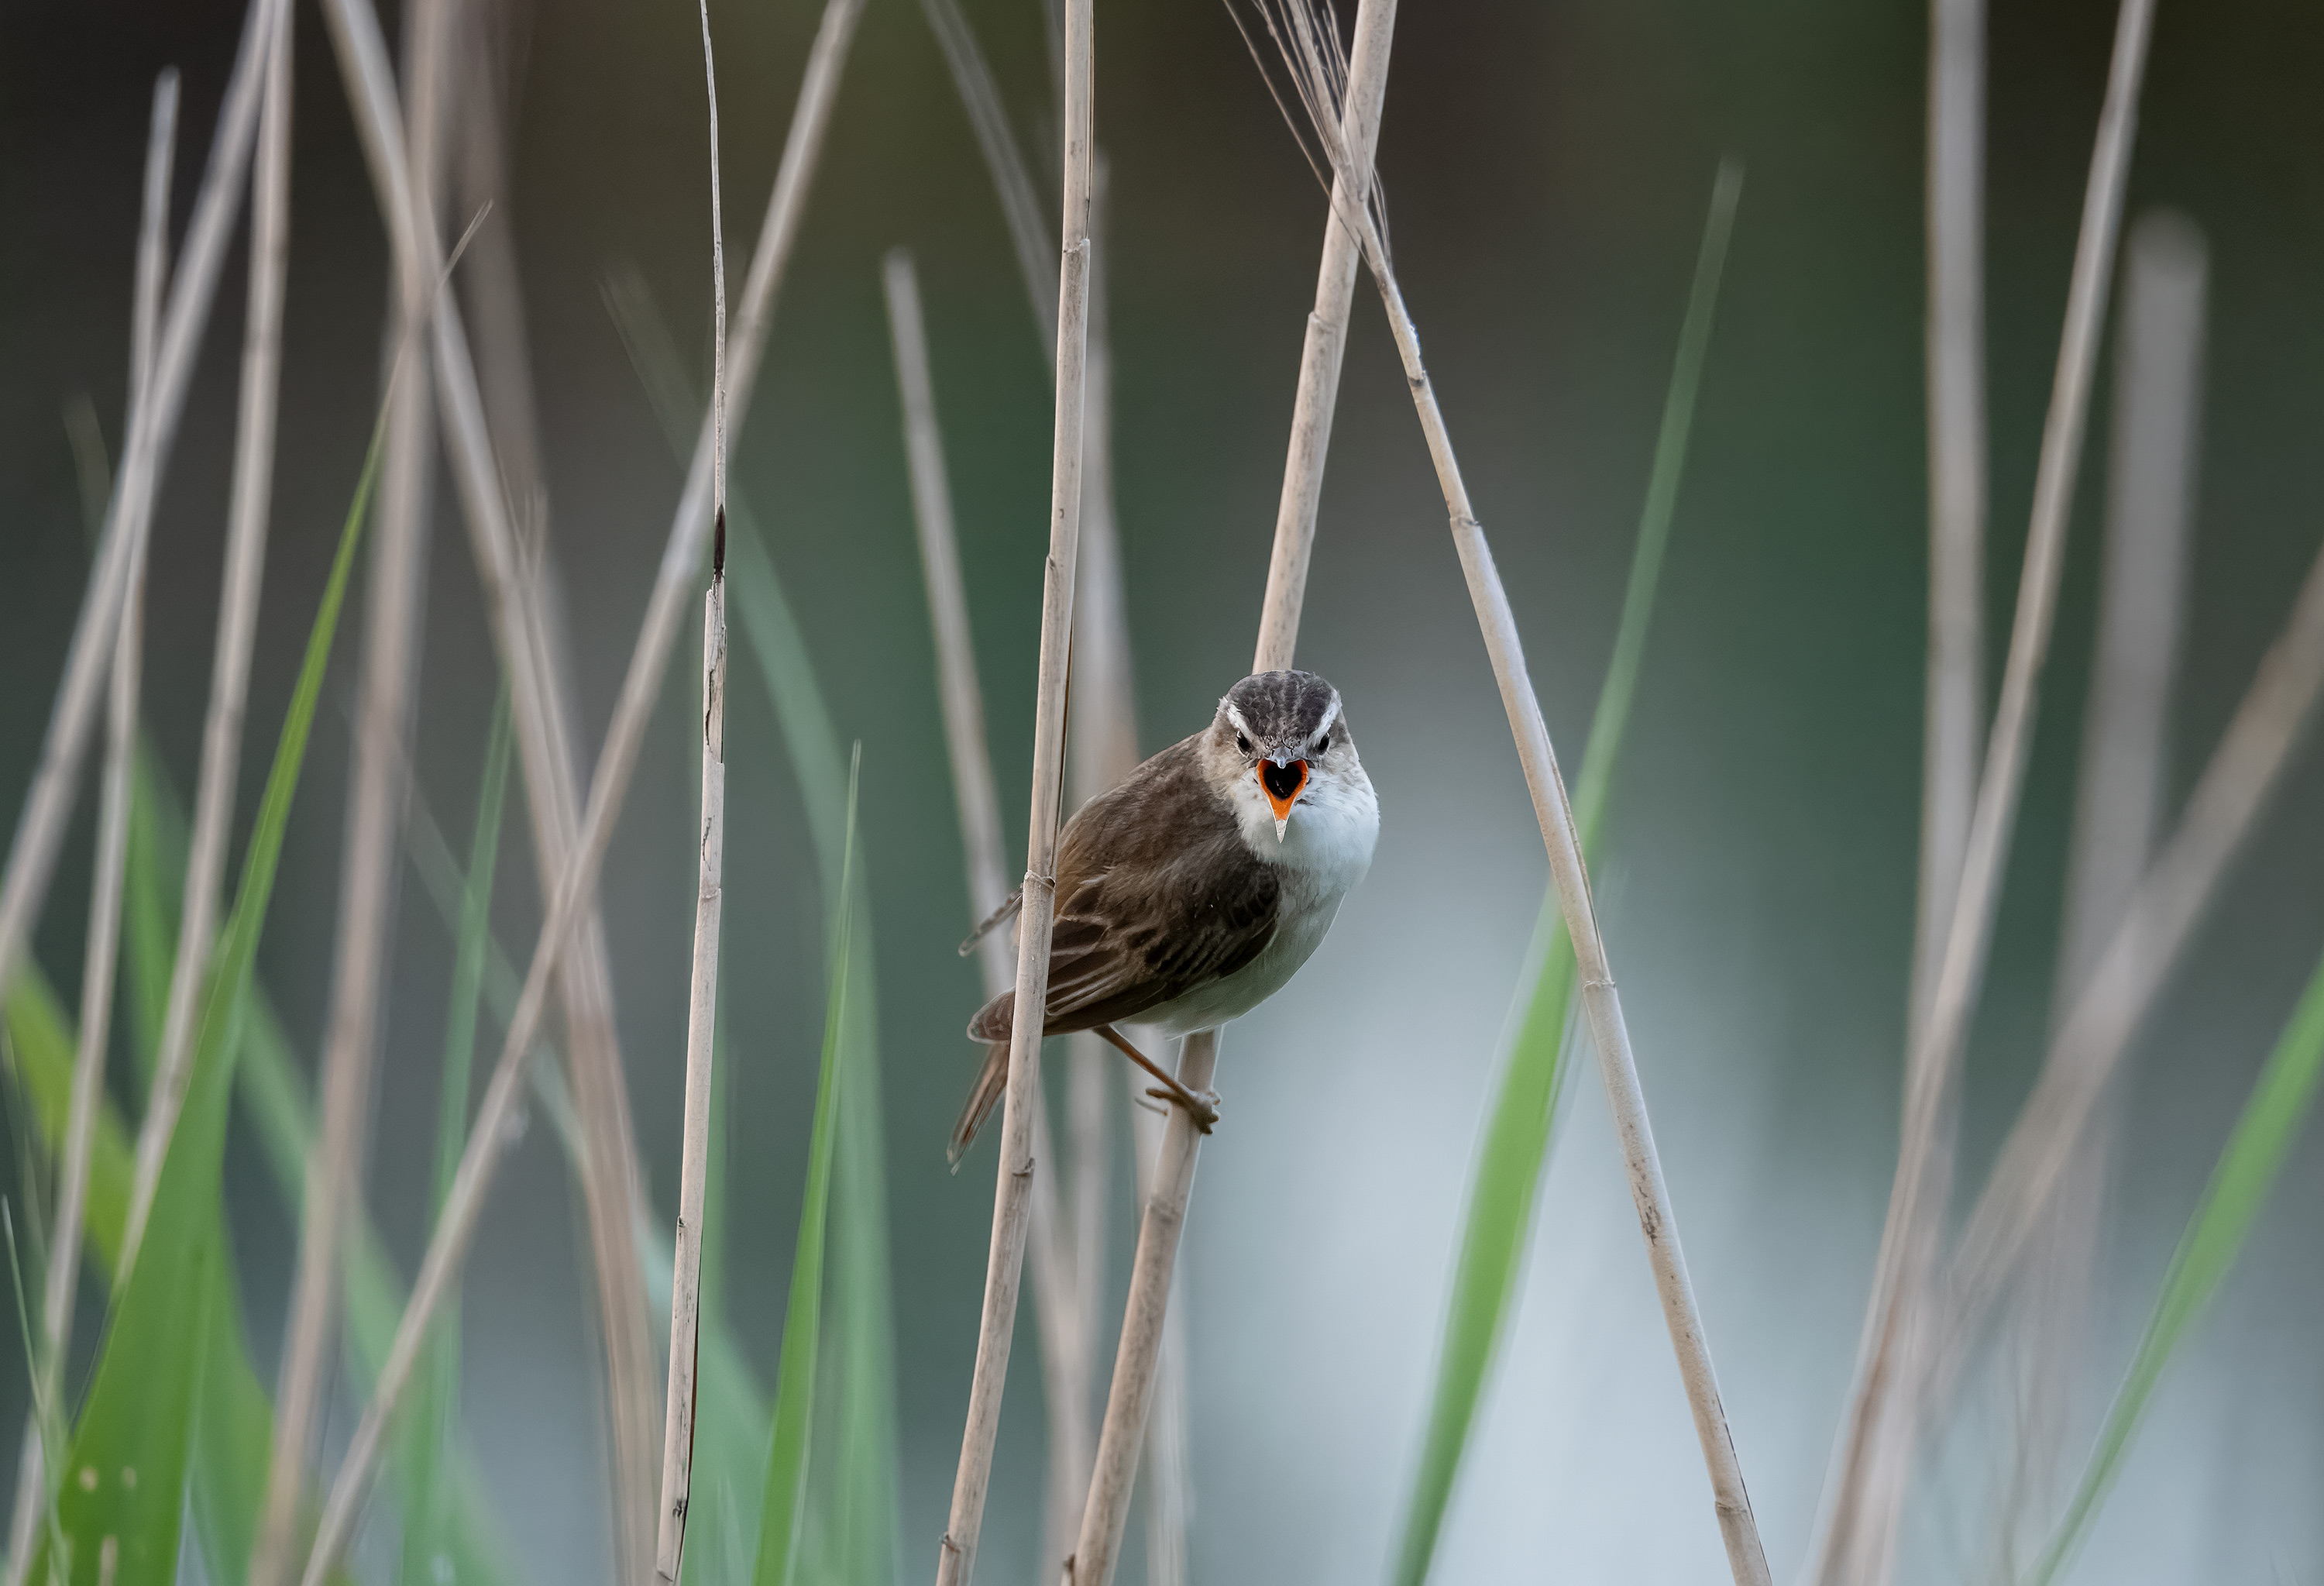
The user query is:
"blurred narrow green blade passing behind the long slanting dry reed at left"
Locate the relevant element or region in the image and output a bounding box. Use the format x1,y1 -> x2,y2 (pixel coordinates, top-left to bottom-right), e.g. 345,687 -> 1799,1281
397,683 -> 516,1586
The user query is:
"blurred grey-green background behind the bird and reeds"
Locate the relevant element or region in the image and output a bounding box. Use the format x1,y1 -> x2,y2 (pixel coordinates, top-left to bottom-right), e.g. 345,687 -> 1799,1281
0,0 -> 2324,1581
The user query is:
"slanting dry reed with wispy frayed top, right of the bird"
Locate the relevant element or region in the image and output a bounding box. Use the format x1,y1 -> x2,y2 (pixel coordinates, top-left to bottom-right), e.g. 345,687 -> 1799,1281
1236,0 -> 1769,1586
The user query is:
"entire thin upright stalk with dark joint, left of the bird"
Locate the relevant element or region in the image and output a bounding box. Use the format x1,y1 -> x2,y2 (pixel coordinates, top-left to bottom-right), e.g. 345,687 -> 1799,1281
653,0 -> 725,1586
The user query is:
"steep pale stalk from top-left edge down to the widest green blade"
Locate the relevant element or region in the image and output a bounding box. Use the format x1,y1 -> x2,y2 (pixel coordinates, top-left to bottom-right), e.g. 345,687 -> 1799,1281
139,7 -> 293,1264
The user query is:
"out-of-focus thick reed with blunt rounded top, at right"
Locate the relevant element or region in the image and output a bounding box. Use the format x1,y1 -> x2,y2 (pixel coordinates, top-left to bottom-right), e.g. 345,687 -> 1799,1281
2003,212 -> 2205,1544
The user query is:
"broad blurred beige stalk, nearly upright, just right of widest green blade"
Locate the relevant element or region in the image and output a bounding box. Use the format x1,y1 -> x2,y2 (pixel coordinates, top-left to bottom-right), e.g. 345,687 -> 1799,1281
251,0 -> 453,1586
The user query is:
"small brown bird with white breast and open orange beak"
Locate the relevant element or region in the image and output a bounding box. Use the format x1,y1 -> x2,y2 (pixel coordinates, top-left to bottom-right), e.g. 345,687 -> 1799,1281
951,672 -> 1380,1168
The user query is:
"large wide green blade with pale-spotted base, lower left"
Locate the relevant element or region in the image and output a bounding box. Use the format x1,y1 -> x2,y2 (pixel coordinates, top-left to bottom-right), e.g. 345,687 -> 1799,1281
30,377 -> 381,1586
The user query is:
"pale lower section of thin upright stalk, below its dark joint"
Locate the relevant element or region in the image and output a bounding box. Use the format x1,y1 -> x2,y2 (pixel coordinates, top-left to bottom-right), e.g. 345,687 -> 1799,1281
653,579 -> 725,1586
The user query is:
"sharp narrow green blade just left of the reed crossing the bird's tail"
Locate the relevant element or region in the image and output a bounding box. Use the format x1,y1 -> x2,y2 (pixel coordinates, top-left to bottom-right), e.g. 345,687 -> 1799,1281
751,753 -> 855,1586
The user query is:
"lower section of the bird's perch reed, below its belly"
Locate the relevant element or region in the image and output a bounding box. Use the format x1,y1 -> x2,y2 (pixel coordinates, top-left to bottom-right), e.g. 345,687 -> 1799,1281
1064,1030 -> 1218,1586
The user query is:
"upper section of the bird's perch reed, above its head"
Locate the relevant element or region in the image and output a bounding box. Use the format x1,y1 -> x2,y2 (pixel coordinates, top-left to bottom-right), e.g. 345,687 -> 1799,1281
1250,0 -> 1397,672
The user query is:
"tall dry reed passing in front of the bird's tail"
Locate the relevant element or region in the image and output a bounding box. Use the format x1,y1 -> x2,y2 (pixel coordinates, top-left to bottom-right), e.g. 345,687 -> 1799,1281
937,0 -> 1095,1586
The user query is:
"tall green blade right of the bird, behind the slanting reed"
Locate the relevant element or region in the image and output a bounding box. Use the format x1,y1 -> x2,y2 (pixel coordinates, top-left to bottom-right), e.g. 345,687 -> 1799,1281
1394,160 -> 1743,1586
